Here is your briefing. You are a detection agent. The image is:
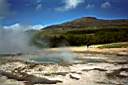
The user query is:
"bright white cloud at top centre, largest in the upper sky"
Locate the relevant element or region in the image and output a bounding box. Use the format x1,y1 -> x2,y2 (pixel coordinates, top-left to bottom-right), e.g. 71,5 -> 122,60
56,0 -> 84,11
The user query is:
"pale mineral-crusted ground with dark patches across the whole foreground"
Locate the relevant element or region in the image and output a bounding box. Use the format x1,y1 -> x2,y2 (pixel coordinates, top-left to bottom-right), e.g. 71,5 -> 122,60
0,53 -> 128,85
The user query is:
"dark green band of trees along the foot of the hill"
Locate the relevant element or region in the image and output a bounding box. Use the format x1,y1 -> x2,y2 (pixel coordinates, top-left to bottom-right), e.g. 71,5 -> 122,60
33,28 -> 128,47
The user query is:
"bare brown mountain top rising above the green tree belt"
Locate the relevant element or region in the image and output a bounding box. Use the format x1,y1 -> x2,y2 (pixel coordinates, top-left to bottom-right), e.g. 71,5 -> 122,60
43,17 -> 128,30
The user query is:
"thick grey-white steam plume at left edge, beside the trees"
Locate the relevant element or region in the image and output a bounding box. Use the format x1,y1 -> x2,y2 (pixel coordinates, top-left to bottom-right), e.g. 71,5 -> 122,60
0,29 -> 32,54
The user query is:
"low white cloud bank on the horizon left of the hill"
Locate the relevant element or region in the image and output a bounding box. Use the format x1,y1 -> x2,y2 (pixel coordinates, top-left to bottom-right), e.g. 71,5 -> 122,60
3,23 -> 44,30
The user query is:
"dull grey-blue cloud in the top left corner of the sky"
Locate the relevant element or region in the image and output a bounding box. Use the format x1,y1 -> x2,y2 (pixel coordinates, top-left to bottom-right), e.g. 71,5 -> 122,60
0,0 -> 9,18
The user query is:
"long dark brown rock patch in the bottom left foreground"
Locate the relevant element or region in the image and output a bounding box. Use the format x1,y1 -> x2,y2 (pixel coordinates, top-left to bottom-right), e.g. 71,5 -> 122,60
1,72 -> 62,85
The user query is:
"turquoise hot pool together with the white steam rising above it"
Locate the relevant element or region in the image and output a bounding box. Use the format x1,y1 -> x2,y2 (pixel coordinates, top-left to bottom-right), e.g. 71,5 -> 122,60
29,48 -> 76,64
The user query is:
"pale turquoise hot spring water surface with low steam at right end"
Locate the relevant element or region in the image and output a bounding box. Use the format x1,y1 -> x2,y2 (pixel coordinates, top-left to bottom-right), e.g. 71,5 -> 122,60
29,52 -> 75,64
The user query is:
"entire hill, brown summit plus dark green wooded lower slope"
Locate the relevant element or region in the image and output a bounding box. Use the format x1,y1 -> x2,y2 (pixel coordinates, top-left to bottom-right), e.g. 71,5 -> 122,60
32,17 -> 128,47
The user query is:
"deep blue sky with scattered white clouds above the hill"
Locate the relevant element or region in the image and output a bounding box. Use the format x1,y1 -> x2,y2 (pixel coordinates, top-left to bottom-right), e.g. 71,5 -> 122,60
0,0 -> 128,29
